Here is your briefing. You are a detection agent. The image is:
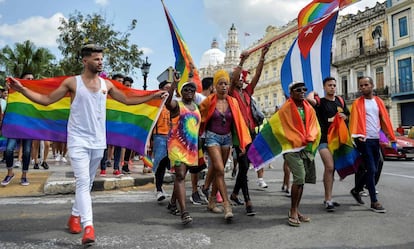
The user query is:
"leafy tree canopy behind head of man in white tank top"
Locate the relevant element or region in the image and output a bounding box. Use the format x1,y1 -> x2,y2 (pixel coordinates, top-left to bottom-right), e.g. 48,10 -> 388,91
57,11 -> 142,75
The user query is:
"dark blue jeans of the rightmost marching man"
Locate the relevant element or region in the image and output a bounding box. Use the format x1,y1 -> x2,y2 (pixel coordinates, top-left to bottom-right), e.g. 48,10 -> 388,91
355,139 -> 380,203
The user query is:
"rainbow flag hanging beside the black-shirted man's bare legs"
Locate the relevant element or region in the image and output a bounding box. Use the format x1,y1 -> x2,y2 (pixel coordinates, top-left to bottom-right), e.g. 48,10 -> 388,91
328,113 -> 362,179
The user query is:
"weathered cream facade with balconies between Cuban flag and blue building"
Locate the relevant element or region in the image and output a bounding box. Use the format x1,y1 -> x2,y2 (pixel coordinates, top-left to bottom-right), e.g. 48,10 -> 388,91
332,3 -> 391,111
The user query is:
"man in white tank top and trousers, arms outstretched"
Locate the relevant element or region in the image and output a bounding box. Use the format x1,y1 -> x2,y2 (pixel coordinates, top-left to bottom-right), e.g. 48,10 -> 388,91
8,44 -> 168,245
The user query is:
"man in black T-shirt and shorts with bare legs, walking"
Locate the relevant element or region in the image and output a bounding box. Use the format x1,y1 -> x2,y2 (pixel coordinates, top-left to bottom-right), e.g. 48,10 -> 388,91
307,77 -> 349,212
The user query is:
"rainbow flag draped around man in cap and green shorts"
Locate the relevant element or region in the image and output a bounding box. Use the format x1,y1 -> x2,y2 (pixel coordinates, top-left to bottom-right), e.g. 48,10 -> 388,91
247,98 -> 321,170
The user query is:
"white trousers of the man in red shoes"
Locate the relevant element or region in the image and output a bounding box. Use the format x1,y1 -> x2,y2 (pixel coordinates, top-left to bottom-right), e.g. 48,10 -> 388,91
68,147 -> 104,227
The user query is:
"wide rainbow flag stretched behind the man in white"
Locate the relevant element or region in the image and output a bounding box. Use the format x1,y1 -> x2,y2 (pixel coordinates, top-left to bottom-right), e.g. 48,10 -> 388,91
2,76 -> 164,155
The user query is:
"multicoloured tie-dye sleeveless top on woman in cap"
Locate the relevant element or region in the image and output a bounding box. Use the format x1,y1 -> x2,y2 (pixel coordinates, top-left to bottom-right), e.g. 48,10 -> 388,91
168,101 -> 201,166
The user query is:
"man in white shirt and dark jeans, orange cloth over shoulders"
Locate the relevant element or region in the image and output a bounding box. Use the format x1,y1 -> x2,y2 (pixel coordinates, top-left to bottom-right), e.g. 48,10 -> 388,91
349,76 -> 396,213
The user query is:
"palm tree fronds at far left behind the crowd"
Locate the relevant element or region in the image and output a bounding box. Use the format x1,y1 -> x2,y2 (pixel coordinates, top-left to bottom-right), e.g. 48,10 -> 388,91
0,40 -> 56,78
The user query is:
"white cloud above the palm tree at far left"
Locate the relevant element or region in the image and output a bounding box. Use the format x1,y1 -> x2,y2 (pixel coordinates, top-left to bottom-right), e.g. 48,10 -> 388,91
0,12 -> 64,47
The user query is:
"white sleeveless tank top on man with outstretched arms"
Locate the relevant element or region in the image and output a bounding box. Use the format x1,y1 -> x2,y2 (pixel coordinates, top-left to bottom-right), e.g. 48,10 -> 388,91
67,75 -> 108,149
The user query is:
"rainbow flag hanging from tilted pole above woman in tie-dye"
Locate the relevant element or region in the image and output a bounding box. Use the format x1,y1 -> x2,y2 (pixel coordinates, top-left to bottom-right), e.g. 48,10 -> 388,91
161,0 -> 202,92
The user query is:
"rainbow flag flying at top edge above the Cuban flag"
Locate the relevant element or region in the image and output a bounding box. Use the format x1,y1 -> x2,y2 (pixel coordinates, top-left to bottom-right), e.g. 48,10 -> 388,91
298,0 -> 360,30
